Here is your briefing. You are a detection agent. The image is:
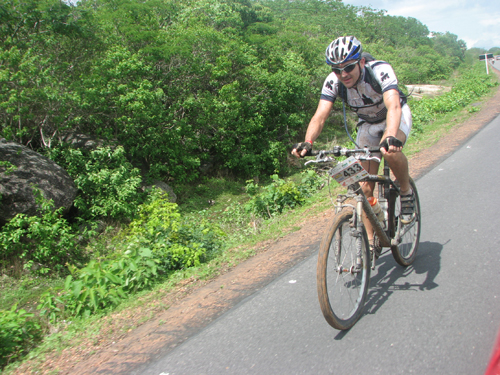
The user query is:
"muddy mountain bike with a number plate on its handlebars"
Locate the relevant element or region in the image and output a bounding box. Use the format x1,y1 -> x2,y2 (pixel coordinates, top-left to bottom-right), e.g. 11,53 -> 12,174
306,146 -> 421,330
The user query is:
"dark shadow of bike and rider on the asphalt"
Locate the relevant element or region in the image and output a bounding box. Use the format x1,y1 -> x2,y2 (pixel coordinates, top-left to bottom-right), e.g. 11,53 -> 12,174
335,241 -> 449,340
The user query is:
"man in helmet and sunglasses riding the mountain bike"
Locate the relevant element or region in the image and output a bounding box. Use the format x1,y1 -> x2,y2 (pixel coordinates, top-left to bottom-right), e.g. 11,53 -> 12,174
292,36 -> 414,247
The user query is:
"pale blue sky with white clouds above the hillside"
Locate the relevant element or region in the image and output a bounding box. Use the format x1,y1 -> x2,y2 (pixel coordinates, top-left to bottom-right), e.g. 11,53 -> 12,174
343,0 -> 500,50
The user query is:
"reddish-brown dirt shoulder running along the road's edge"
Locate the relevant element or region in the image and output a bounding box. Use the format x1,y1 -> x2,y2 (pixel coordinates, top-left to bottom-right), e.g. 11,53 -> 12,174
11,69 -> 500,375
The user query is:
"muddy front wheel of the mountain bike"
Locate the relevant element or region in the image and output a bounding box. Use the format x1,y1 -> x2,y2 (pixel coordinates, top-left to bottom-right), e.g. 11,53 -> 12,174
316,210 -> 370,330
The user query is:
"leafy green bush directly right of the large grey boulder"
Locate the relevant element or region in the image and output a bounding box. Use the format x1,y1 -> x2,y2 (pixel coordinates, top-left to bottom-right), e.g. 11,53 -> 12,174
49,146 -> 143,220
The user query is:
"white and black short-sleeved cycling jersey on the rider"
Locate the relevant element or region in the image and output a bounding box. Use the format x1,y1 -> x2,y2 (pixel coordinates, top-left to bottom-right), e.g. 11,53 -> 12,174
321,60 -> 406,123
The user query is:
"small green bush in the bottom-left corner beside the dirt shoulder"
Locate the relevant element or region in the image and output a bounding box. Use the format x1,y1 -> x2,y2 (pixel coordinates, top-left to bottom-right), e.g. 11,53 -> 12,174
0,305 -> 42,369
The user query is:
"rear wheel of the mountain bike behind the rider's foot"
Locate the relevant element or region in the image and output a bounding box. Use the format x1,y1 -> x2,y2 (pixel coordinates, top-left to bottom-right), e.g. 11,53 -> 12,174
391,178 -> 422,267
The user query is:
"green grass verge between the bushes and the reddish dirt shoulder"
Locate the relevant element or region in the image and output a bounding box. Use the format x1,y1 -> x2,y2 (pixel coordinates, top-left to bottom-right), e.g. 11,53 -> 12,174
0,66 -> 496,374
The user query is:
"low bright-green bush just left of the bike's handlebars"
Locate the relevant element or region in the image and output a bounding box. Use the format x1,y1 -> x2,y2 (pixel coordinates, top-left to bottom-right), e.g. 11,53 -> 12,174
245,169 -> 320,218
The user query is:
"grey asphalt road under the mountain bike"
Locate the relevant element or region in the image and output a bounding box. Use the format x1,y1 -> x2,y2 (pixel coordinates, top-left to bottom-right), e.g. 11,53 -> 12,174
132,113 -> 500,375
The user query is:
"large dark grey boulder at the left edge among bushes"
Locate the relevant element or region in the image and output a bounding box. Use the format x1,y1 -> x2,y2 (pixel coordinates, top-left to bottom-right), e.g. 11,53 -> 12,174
0,139 -> 77,225
